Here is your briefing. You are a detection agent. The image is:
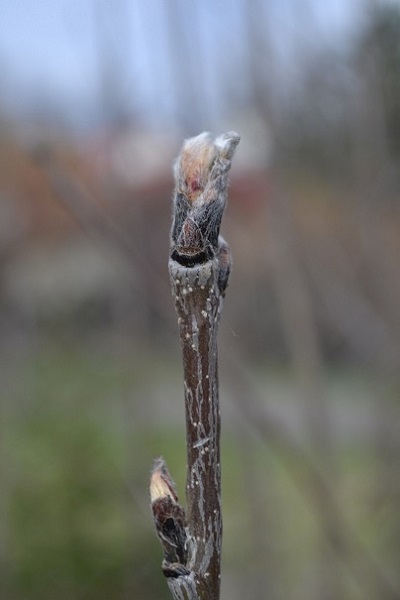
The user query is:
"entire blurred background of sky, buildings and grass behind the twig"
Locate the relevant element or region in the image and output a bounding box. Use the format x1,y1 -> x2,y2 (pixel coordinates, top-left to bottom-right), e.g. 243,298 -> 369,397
0,0 -> 400,600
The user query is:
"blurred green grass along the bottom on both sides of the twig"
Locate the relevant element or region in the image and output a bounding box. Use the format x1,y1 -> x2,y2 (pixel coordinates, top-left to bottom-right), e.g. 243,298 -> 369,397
1,340 -> 395,600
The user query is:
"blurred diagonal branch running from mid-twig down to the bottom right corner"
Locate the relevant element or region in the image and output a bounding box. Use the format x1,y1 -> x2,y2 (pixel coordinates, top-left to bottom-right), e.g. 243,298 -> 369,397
225,357 -> 400,599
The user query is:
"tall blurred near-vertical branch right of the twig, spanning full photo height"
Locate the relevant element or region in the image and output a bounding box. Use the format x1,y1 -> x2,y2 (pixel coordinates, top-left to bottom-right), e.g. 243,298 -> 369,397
248,2 -> 345,600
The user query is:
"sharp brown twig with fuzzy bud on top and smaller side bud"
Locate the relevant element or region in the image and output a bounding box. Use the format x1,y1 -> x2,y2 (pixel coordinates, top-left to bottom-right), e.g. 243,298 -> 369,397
150,132 -> 240,600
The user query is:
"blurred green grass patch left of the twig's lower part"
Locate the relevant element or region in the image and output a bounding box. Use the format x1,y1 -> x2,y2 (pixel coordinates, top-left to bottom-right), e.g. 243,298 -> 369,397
1,347 -> 169,599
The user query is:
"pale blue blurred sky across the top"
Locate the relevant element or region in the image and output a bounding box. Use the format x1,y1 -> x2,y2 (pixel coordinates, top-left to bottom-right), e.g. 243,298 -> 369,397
0,0 -> 365,131
